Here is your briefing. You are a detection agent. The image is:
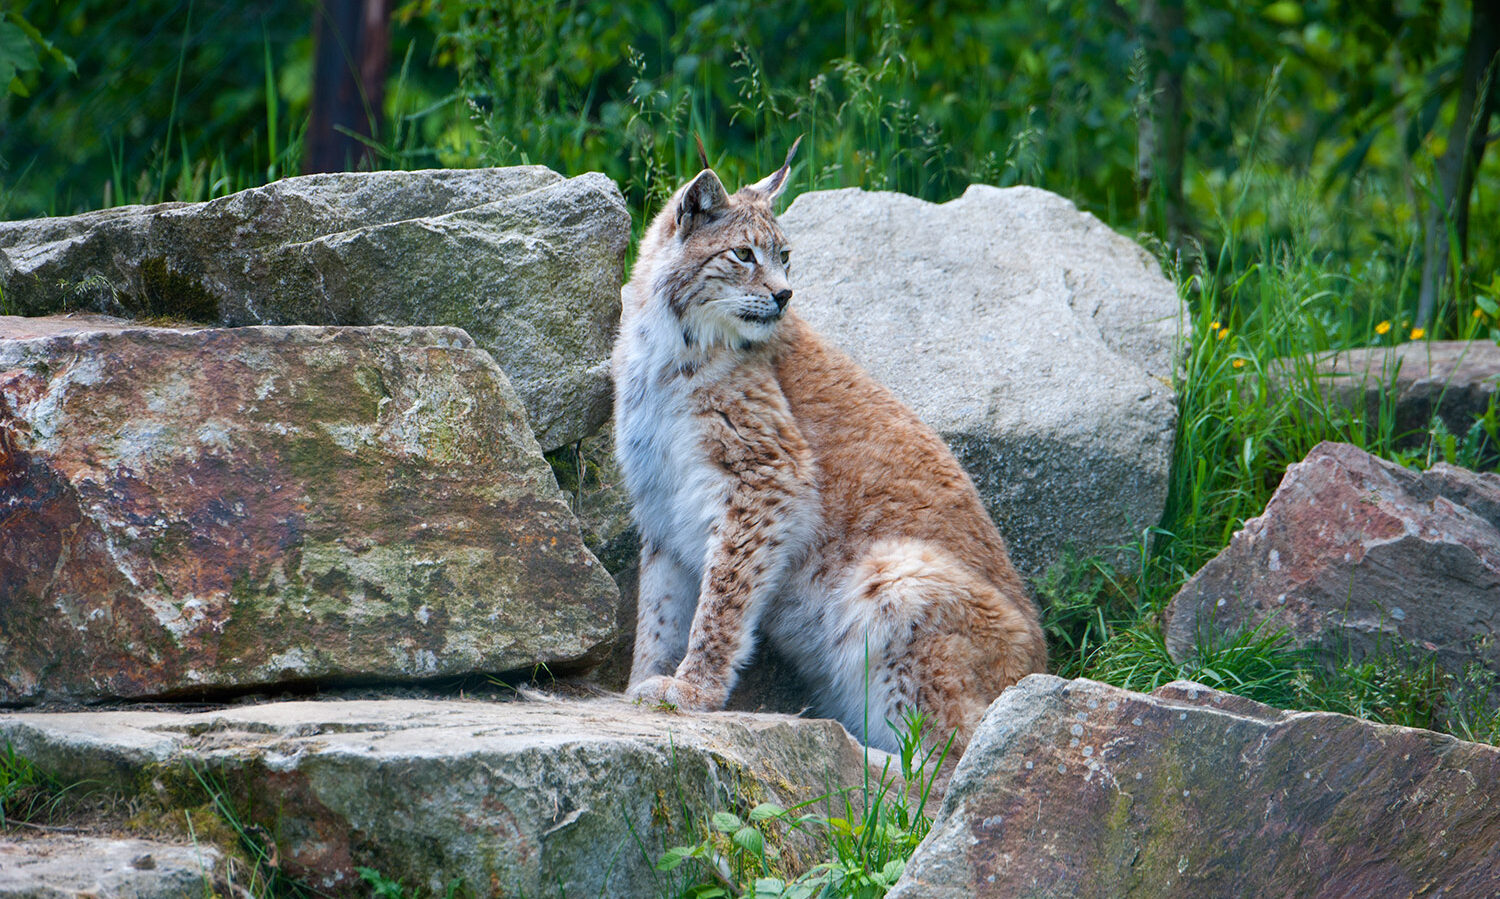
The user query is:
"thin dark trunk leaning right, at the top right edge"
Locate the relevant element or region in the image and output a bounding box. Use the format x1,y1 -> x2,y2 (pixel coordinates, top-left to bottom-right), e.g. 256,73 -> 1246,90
1416,0 -> 1500,329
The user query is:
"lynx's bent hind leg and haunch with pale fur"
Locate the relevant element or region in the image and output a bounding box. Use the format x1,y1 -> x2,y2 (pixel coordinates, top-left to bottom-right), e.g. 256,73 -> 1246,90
833,539 -> 1047,758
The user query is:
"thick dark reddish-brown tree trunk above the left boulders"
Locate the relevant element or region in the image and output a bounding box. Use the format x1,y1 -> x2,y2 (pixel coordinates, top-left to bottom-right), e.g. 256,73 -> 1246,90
303,0 -> 390,173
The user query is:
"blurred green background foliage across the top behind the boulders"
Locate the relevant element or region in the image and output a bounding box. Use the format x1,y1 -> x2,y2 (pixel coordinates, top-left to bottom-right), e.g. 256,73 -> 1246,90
0,0 -> 1500,327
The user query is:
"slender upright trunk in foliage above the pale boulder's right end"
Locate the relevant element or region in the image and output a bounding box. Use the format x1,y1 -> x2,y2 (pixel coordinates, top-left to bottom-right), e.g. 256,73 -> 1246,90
1136,0 -> 1191,243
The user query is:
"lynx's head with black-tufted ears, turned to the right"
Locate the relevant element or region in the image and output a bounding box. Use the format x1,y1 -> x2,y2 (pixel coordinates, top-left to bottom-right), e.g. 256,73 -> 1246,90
641,140 -> 801,348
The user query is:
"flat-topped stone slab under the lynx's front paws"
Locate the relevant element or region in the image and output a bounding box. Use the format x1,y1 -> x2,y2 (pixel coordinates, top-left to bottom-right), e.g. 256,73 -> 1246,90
0,699 -> 864,896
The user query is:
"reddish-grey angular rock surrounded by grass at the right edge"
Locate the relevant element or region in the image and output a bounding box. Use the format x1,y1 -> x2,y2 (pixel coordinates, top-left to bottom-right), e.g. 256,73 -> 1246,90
1167,443 -> 1500,671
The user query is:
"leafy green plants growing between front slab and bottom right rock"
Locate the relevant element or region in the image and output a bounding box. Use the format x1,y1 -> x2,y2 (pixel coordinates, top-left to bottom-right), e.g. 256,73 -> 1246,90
657,711 -> 953,899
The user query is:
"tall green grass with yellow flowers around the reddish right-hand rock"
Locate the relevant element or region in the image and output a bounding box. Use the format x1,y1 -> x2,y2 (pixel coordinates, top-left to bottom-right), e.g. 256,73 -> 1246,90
1037,133 -> 1500,740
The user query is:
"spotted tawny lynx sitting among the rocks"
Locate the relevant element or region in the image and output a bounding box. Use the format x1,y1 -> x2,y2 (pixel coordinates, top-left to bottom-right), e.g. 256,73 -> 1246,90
614,146 -> 1046,753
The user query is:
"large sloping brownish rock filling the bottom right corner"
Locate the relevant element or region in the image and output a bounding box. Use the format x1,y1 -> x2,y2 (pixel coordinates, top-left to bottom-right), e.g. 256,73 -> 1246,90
890,675 -> 1500,899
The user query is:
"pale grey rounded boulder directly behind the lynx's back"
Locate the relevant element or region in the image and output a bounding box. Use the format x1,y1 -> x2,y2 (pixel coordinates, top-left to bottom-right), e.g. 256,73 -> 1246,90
782,185 -> 1185,578
